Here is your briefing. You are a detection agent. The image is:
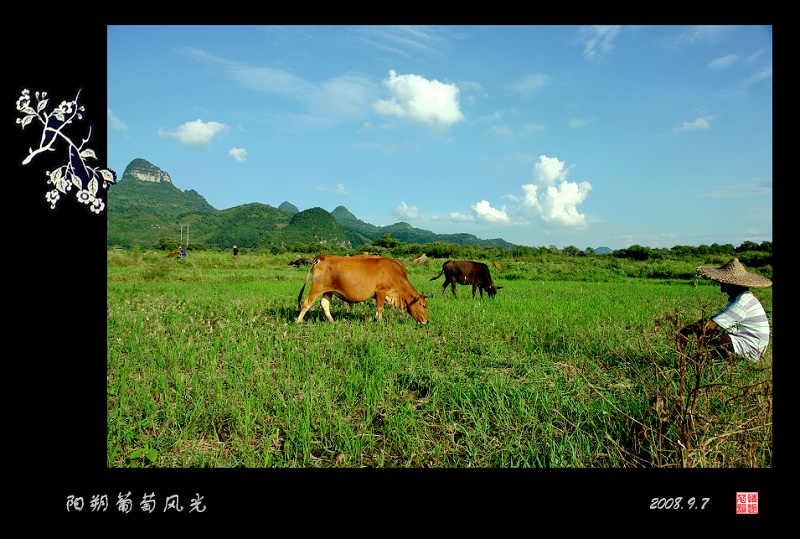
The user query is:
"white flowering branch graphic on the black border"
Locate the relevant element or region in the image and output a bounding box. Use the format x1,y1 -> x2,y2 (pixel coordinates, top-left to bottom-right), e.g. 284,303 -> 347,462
17,89 -> 117,215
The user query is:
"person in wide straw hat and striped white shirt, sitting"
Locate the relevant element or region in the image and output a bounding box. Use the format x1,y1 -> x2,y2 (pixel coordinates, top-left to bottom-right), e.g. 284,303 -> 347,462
680,258 -> 772,362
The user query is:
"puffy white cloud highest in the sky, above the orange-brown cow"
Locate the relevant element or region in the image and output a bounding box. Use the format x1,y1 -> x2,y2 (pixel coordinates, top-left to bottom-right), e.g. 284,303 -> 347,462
373,69 -> 464,127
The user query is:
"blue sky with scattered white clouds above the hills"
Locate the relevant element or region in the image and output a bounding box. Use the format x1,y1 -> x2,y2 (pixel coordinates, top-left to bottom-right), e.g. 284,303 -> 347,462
107,25 -> 772,249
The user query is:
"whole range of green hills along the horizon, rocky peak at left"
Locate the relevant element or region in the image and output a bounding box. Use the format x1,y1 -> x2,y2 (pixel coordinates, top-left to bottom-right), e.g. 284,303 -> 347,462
107,158 -> 556,249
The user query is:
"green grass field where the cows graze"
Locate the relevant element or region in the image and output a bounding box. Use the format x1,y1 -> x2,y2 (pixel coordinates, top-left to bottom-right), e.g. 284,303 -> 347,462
107,251 -> 772,468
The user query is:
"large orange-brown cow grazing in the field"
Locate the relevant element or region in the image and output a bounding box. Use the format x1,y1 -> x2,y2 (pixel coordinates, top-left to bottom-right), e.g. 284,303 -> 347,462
296,255 -> 428,324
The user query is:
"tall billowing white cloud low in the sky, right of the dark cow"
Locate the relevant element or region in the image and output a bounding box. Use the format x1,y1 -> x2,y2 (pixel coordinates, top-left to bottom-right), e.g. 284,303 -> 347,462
518,155 -> 592,228
